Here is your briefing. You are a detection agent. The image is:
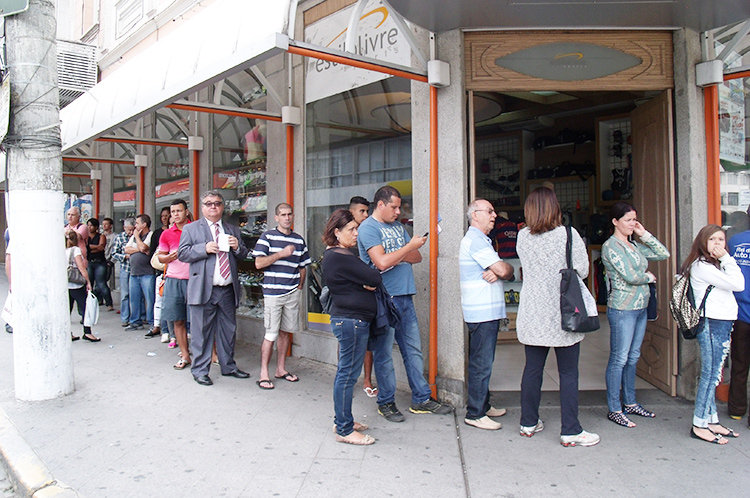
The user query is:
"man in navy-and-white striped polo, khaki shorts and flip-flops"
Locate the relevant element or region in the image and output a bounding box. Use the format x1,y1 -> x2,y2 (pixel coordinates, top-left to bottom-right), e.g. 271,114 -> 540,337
253,203 -> 310,389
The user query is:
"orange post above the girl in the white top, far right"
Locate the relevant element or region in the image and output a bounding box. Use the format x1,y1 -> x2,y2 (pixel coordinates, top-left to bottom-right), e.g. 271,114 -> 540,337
703,85 -> 721,226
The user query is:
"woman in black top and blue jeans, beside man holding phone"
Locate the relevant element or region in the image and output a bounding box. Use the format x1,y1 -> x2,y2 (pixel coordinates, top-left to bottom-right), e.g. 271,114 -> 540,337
323,209 -> 382,445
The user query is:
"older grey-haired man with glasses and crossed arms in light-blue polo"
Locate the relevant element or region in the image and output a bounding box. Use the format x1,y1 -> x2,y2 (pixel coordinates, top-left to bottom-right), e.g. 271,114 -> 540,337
458,199 -> 513,430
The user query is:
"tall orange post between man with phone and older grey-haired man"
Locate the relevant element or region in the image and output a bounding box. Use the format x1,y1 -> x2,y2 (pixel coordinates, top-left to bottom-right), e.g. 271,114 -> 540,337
429,86 -> 438,399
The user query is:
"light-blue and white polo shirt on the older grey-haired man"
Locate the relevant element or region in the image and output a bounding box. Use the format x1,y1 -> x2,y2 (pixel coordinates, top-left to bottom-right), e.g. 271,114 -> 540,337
458,227 -> 505,323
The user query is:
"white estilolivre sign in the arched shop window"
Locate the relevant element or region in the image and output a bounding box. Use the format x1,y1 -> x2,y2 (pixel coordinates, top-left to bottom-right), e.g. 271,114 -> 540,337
305,1 -> 411,103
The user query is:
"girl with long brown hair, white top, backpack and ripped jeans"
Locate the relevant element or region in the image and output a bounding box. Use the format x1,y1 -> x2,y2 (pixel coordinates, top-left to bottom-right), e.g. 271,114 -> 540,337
682,225 -> 745,444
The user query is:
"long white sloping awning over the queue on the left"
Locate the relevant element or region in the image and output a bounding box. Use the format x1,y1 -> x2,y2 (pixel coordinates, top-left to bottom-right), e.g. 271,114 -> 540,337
60,0 -> 289,153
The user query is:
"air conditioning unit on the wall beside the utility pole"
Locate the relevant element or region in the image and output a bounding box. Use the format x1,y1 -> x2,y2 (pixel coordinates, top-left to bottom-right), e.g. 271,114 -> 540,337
57,40 -> 99,109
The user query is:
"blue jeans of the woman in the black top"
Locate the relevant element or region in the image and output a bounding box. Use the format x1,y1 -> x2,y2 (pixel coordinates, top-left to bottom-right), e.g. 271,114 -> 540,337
331,316 -> 370,436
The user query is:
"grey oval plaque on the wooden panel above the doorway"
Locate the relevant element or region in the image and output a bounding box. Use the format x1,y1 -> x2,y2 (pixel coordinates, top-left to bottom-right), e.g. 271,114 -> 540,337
495,42 -> 643,81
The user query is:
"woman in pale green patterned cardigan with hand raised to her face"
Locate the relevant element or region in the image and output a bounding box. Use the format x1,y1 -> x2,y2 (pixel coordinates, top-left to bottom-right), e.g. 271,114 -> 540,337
602,202 -> 669,427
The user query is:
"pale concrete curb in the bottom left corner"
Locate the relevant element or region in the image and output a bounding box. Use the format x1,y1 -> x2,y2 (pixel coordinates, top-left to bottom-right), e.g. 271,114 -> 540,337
0,408 -> 83,498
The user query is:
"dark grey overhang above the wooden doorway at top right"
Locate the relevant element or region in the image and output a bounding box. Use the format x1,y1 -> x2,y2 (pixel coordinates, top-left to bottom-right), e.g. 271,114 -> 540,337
390,0 -> 750,32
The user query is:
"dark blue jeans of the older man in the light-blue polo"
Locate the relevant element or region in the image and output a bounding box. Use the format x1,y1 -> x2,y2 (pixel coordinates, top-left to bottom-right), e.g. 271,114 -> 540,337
466,320 -> 500,420
